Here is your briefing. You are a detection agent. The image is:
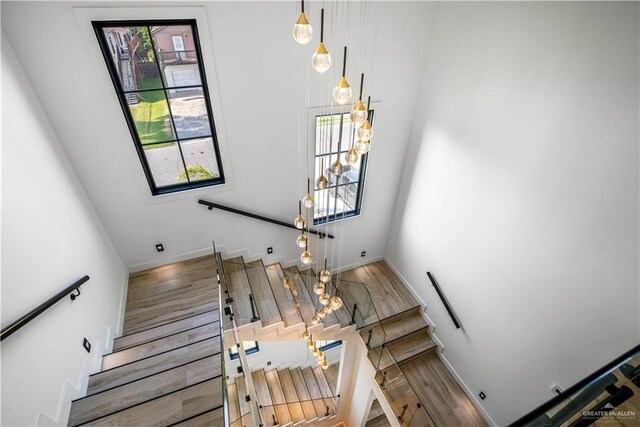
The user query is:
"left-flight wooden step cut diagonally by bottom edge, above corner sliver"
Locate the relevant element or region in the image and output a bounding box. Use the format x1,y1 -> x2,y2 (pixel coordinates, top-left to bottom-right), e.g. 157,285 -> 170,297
75,377 -> 222,427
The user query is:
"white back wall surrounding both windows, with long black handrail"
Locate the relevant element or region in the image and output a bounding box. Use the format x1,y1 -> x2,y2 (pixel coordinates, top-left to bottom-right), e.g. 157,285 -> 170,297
2,2 -> 434,269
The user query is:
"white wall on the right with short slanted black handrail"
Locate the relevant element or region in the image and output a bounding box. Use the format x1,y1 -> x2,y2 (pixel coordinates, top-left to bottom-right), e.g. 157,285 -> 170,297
386,2 -> 640,425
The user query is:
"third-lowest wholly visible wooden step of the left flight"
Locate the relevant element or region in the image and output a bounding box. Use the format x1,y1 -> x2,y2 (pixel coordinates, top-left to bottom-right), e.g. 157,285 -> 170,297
102,322 -> 220,370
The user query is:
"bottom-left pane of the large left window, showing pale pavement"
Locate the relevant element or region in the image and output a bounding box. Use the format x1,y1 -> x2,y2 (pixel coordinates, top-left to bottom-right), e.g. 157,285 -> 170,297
144,142 -> 187,187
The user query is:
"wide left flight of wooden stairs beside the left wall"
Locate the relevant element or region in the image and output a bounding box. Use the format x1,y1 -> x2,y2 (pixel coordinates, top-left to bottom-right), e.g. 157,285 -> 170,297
69,256 -> 223,426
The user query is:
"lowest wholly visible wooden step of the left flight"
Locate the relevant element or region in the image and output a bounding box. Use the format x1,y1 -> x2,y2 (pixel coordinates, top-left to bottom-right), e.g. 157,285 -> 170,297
69,354 -> 221,426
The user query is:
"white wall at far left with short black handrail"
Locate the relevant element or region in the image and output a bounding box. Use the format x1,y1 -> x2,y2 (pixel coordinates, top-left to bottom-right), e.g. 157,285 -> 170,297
0,34 -> 127,426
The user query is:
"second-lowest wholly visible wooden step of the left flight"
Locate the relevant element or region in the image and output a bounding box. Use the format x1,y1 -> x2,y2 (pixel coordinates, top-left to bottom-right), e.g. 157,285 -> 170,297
87,336 -> 220,395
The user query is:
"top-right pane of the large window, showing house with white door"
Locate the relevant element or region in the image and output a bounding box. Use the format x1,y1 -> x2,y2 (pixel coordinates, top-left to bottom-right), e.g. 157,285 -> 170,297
151,25 -> 202,87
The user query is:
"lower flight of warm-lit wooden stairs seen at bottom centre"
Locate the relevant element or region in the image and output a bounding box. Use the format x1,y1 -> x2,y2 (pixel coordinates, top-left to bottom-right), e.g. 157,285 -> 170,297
227,364 -> 338,427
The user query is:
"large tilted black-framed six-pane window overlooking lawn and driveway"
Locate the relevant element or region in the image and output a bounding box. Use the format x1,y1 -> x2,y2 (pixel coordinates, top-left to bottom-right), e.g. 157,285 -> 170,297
93,20 -> 225,195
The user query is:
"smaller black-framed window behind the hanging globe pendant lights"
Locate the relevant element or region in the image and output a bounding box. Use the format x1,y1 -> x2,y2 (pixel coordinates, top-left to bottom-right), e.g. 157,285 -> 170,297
313,110 -> 373,225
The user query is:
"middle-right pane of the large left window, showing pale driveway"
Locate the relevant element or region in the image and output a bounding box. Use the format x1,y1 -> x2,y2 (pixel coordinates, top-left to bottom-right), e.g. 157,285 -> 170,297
167,88 -> 211,138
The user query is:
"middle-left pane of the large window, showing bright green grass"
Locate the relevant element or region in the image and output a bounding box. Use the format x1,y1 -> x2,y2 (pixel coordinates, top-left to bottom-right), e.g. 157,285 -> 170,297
125,90 -> 175,144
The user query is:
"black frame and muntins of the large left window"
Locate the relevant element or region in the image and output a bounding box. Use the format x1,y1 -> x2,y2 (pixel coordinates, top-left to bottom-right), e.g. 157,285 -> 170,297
91,19 -> 226,196
